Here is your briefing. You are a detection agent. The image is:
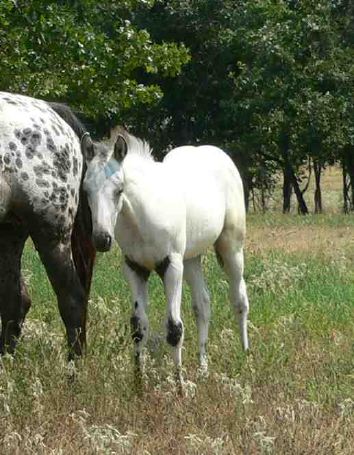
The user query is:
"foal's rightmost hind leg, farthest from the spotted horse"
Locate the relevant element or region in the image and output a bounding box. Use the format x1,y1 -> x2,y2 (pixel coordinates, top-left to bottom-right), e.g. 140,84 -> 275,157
215,234 -> 249,351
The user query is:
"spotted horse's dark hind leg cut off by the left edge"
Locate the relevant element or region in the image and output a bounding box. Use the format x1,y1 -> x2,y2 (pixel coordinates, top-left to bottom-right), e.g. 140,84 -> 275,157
0,223 -> 31,354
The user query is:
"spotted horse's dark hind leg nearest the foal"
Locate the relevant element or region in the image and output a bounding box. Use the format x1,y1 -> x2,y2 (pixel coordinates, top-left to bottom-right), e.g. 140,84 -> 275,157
31,229 -> 87,360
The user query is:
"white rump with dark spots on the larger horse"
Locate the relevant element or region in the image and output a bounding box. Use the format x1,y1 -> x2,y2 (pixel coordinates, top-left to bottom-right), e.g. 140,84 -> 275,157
0,92 -> 82,235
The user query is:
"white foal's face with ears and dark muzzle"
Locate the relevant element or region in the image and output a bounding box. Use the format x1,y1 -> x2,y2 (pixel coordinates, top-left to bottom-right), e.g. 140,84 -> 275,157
82,136 -> 127,251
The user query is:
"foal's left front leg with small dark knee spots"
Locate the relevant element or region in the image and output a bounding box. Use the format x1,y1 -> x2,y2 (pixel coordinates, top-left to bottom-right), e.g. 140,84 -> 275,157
123,259 -> 150,379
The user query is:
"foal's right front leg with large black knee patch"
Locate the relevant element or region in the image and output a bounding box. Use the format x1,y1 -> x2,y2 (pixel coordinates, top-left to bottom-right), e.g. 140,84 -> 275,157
162,254 -> 183,385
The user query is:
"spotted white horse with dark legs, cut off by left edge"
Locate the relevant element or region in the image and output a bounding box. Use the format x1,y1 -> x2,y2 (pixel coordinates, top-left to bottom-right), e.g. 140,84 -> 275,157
0,92 -> 95,358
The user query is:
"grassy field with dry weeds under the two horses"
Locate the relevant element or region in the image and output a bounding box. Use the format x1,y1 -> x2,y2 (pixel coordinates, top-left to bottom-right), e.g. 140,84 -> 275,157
0,172 -> 354,455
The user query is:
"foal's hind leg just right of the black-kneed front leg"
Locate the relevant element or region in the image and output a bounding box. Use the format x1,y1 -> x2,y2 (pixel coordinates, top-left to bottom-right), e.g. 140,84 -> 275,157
183,256 -> 210,371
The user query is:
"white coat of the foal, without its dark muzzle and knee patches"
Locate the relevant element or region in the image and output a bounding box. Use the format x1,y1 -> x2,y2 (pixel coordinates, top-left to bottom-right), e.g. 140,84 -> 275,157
85,135 -> 248,376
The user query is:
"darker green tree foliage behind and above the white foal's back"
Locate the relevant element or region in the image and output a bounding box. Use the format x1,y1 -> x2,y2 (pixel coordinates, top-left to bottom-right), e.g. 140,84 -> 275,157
131,0 -> 354,209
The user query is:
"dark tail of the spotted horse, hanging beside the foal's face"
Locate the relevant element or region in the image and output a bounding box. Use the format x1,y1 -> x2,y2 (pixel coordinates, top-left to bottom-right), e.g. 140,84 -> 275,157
48,103 -> 96,298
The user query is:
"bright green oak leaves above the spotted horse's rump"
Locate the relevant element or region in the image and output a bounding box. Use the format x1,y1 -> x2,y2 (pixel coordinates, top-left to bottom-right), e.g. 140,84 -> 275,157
0,0 -> 188,119
